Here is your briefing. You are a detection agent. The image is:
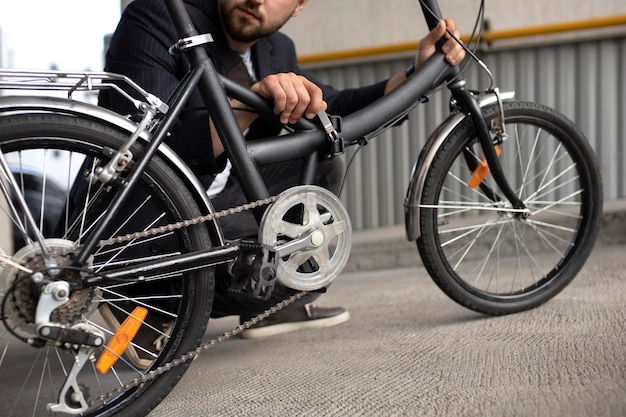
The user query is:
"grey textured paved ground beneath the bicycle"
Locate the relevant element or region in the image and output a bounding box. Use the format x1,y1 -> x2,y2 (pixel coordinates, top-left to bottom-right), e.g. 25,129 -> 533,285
151,240 -> 626,417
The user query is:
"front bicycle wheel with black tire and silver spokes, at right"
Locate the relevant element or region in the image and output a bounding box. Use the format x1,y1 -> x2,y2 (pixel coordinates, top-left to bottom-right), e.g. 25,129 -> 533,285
417,101 -> 602,315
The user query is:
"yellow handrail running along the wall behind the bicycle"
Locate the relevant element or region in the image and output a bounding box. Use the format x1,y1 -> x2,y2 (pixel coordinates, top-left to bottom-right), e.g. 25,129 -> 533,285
298,14 -> 626,64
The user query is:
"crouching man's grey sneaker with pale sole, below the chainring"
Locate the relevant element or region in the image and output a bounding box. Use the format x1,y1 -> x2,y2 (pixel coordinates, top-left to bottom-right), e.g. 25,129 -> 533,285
239,304 -> 350,339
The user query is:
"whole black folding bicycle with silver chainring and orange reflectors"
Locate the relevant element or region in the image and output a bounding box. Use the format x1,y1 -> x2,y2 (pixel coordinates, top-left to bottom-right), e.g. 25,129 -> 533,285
7,0 -> 602,415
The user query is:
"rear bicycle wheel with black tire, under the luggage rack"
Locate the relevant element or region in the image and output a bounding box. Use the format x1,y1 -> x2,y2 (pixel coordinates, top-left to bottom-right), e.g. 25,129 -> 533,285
0,113 -> 214,416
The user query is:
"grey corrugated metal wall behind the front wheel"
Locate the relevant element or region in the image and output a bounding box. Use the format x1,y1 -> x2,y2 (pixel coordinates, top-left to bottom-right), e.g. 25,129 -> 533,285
308,37 -> 626,229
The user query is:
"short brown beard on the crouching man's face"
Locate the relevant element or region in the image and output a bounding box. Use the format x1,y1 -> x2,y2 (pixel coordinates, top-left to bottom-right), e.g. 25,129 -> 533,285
219,0 -> 291,43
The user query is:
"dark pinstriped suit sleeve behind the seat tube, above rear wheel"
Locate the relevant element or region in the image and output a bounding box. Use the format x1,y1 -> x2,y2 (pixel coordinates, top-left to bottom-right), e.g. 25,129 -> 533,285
99,1 -> 225,175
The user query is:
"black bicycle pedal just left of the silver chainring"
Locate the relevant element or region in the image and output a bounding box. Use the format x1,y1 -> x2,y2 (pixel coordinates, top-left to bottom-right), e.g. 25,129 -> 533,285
228,241 -> 278,300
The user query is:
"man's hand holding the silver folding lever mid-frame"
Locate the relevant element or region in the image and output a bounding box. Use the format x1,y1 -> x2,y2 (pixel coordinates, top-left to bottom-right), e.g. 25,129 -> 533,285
252,72 -> 326,124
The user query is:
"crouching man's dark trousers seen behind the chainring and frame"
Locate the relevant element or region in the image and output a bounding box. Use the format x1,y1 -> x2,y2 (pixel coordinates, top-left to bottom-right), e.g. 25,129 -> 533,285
211,158 -> 343,317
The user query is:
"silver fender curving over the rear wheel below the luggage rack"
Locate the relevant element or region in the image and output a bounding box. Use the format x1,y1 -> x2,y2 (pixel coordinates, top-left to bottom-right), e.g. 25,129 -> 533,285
0,96 -> 224,245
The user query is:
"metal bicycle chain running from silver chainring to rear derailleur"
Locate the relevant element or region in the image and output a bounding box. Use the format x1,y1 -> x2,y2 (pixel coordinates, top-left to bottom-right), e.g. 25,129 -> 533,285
89,196 -> 308,407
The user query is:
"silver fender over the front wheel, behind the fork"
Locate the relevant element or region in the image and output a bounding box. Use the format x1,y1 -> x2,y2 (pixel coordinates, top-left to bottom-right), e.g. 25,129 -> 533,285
404,91 -> 515,241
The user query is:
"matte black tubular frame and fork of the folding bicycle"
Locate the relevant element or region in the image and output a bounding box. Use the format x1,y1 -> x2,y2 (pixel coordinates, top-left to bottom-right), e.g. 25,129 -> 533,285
76,0 -> 523,285
